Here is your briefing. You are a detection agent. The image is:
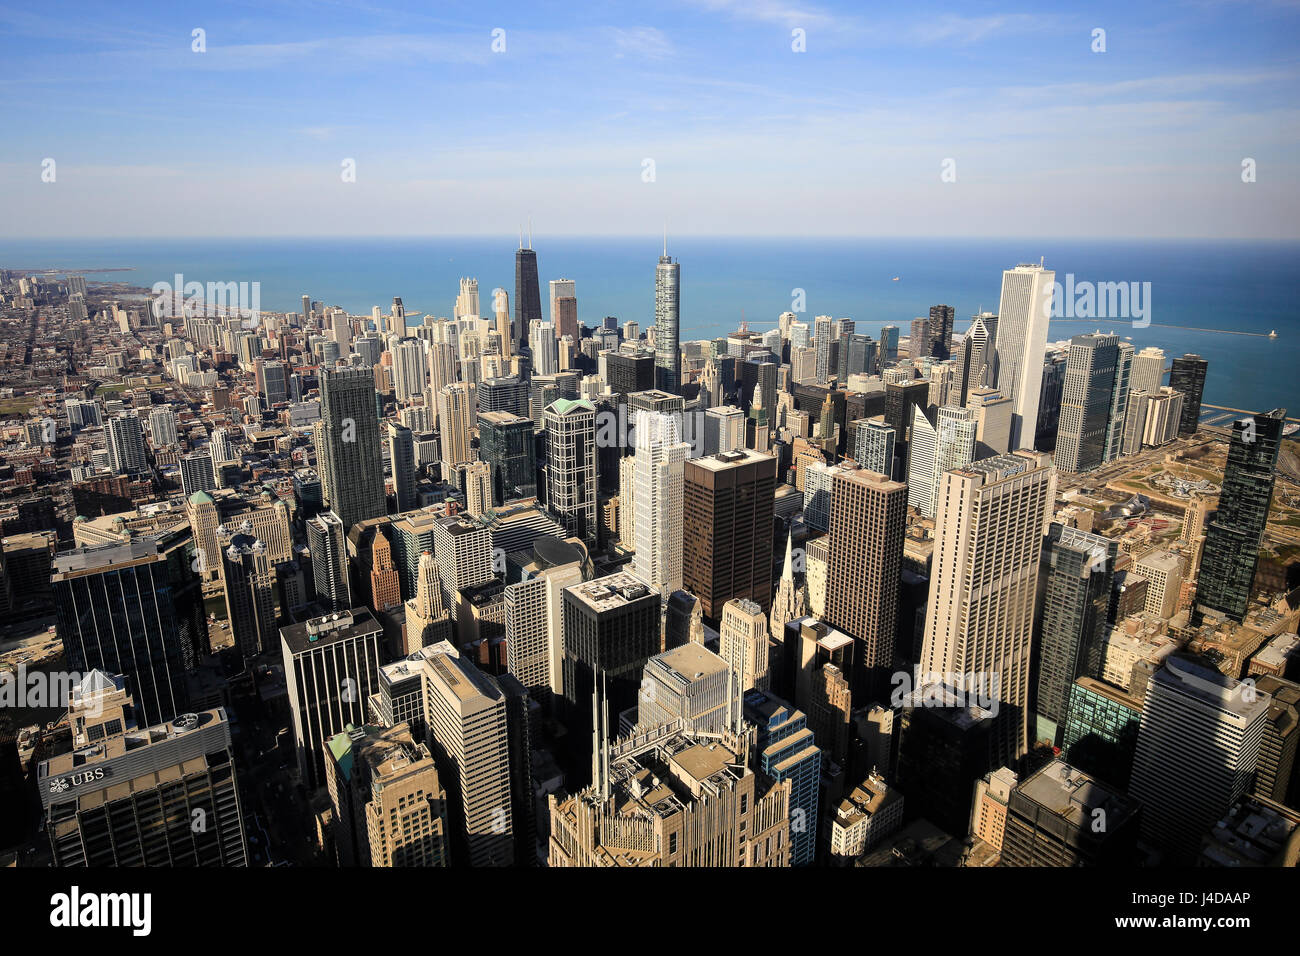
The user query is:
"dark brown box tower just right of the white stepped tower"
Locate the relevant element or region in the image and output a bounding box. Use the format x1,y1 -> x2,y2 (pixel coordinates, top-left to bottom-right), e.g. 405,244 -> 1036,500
681,449 -> 776,623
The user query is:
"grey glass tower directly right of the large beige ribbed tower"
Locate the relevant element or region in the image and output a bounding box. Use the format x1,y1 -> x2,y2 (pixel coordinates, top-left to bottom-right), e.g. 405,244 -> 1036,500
1035,523 -> 1119,745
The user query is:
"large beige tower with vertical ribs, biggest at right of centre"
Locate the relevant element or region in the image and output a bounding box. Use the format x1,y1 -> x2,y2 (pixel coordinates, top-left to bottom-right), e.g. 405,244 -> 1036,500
919,451 -> 1056,765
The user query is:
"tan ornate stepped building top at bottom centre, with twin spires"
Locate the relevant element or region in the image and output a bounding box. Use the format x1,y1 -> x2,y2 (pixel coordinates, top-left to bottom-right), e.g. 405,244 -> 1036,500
547,724 -> 790,866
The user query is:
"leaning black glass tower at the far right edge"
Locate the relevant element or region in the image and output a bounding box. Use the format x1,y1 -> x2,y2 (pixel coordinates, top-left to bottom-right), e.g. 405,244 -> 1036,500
1196,408 -> 1287,622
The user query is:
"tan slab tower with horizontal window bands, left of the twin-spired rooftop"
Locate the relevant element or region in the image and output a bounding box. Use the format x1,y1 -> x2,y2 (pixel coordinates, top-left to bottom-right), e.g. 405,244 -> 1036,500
424,643 -> 514,866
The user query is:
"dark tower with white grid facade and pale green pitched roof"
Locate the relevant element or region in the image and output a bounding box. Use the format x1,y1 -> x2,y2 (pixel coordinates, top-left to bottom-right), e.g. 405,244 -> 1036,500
543,398 -> 599,545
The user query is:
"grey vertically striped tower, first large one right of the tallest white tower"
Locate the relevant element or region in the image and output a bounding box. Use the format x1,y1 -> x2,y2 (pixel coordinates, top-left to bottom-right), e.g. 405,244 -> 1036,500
1056,333 -> 1119,472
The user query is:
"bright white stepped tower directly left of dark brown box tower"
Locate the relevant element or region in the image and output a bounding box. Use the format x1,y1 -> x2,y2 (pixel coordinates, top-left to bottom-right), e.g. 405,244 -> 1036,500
632,410 -> 690,597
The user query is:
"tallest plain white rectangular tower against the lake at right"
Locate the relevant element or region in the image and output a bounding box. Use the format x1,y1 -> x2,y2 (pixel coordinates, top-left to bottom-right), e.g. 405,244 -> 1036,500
996,263 -> 1056,449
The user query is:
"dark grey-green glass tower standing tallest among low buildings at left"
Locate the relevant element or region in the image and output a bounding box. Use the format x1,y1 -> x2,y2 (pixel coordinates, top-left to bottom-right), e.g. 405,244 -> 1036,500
317,367 -> 389,531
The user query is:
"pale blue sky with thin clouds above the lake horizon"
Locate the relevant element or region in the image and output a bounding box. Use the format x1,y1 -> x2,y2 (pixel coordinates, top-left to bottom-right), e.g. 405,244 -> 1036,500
0,0 -> 1300,238
